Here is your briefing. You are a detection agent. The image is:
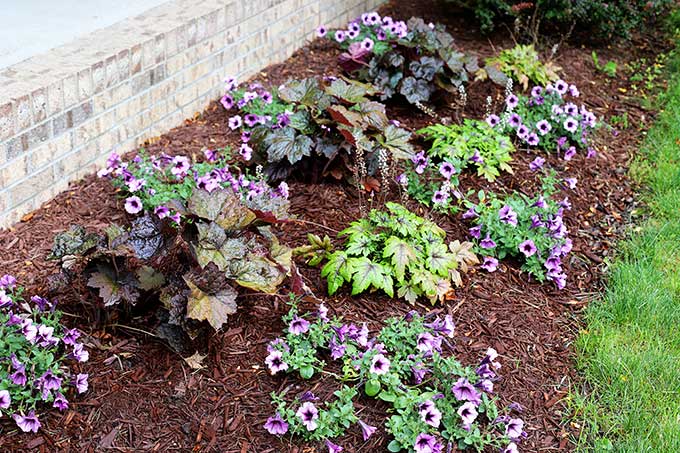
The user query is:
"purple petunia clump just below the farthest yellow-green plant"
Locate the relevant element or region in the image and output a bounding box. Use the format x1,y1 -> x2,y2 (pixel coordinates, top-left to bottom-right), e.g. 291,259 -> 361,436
486,80 -> 598,160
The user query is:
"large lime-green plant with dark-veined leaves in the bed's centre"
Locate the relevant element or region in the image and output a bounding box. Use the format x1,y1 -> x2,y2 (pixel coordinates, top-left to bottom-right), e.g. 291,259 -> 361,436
298,203 -> 477,304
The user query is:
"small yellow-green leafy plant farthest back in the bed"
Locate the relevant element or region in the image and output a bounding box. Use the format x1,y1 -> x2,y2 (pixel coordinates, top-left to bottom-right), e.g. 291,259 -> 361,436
484,44 -> 561,90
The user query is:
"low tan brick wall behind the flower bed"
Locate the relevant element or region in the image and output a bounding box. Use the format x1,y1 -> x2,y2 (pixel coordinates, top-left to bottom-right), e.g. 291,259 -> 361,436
0,0 -> 382,228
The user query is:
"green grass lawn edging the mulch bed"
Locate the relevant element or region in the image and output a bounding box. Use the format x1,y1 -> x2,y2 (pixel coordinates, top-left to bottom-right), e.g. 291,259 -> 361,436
570,38 -> 680,453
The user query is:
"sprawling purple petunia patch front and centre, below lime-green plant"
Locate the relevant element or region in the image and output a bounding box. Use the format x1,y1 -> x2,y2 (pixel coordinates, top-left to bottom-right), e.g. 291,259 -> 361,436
265,301 -> 526,453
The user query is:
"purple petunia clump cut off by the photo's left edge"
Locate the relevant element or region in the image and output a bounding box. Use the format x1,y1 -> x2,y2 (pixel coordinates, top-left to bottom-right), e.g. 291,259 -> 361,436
0,275 -> 89,433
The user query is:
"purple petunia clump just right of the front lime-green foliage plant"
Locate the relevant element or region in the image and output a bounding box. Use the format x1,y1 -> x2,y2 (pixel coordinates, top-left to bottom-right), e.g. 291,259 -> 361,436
463,174 -> 575,289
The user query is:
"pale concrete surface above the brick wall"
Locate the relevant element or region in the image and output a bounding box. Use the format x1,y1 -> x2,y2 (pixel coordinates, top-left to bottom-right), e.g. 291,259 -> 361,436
0,0 -> 167,69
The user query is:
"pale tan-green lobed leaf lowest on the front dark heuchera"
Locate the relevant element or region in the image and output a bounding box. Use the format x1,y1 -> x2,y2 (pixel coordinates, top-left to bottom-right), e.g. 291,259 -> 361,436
184,276 -> 238,330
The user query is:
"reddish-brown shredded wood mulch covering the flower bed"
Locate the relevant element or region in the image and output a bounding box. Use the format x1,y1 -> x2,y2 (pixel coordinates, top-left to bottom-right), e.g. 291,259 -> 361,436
0,0 -> 664,453
